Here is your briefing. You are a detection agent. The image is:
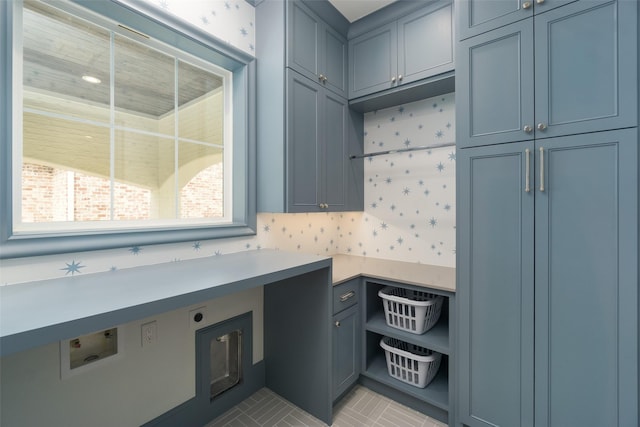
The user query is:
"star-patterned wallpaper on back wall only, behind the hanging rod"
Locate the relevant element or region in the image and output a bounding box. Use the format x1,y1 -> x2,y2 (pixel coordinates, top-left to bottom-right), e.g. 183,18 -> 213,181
356,94 -> 456,267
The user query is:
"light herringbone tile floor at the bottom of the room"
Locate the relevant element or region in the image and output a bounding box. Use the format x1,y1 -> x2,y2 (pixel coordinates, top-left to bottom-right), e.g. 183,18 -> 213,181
205,385 -> 446,427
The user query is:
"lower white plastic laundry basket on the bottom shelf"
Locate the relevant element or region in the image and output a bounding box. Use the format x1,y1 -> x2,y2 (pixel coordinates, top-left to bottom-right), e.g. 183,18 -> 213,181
380,337 -> 442,388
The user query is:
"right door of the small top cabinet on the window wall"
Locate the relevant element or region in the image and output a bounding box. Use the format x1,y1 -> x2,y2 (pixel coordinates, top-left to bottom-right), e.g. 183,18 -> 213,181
320,25 -> 347,98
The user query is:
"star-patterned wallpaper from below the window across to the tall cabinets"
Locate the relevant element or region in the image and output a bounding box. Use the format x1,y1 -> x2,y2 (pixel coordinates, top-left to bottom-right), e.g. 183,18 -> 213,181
0,94 -> 456,285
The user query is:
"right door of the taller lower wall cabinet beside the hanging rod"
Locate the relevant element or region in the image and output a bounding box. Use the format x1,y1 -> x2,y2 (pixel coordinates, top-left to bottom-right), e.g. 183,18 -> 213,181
320,91 -> 350,211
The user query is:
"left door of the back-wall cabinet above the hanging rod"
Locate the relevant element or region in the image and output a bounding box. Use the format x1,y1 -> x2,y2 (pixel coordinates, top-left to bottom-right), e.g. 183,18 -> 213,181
349,22 -> 398,99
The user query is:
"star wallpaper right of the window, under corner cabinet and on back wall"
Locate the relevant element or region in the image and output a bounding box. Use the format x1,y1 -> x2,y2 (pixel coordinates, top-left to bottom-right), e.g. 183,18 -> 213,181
258,94 -> 456,267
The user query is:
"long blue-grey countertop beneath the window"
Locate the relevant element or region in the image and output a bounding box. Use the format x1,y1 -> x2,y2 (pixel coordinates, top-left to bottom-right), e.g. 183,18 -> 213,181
0,249 -> 332,357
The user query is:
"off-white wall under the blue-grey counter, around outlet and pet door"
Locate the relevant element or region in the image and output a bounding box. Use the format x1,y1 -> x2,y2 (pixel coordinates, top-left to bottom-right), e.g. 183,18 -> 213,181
0,288 -> 263,427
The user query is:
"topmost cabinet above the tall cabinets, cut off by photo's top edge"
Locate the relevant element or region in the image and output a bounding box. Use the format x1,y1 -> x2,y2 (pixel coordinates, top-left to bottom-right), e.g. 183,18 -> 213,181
456,0 -> 576,40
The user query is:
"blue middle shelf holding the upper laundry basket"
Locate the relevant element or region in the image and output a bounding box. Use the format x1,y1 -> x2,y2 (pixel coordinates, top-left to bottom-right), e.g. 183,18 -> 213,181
366,310 -> 450,355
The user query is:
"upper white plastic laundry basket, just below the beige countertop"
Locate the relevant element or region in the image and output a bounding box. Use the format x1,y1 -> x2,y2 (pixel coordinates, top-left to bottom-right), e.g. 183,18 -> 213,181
378,286 -> 444,334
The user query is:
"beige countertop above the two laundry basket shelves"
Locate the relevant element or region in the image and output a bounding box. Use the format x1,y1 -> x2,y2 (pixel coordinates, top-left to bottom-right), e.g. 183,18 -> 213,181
332,255 -> 456,292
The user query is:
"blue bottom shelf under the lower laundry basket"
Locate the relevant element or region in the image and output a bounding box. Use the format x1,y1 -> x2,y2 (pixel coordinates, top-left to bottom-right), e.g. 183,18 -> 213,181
362,349 -> 449,411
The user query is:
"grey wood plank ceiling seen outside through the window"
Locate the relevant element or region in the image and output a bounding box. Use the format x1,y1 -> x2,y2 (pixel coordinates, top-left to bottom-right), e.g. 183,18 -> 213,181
23,1 -> 222,118
